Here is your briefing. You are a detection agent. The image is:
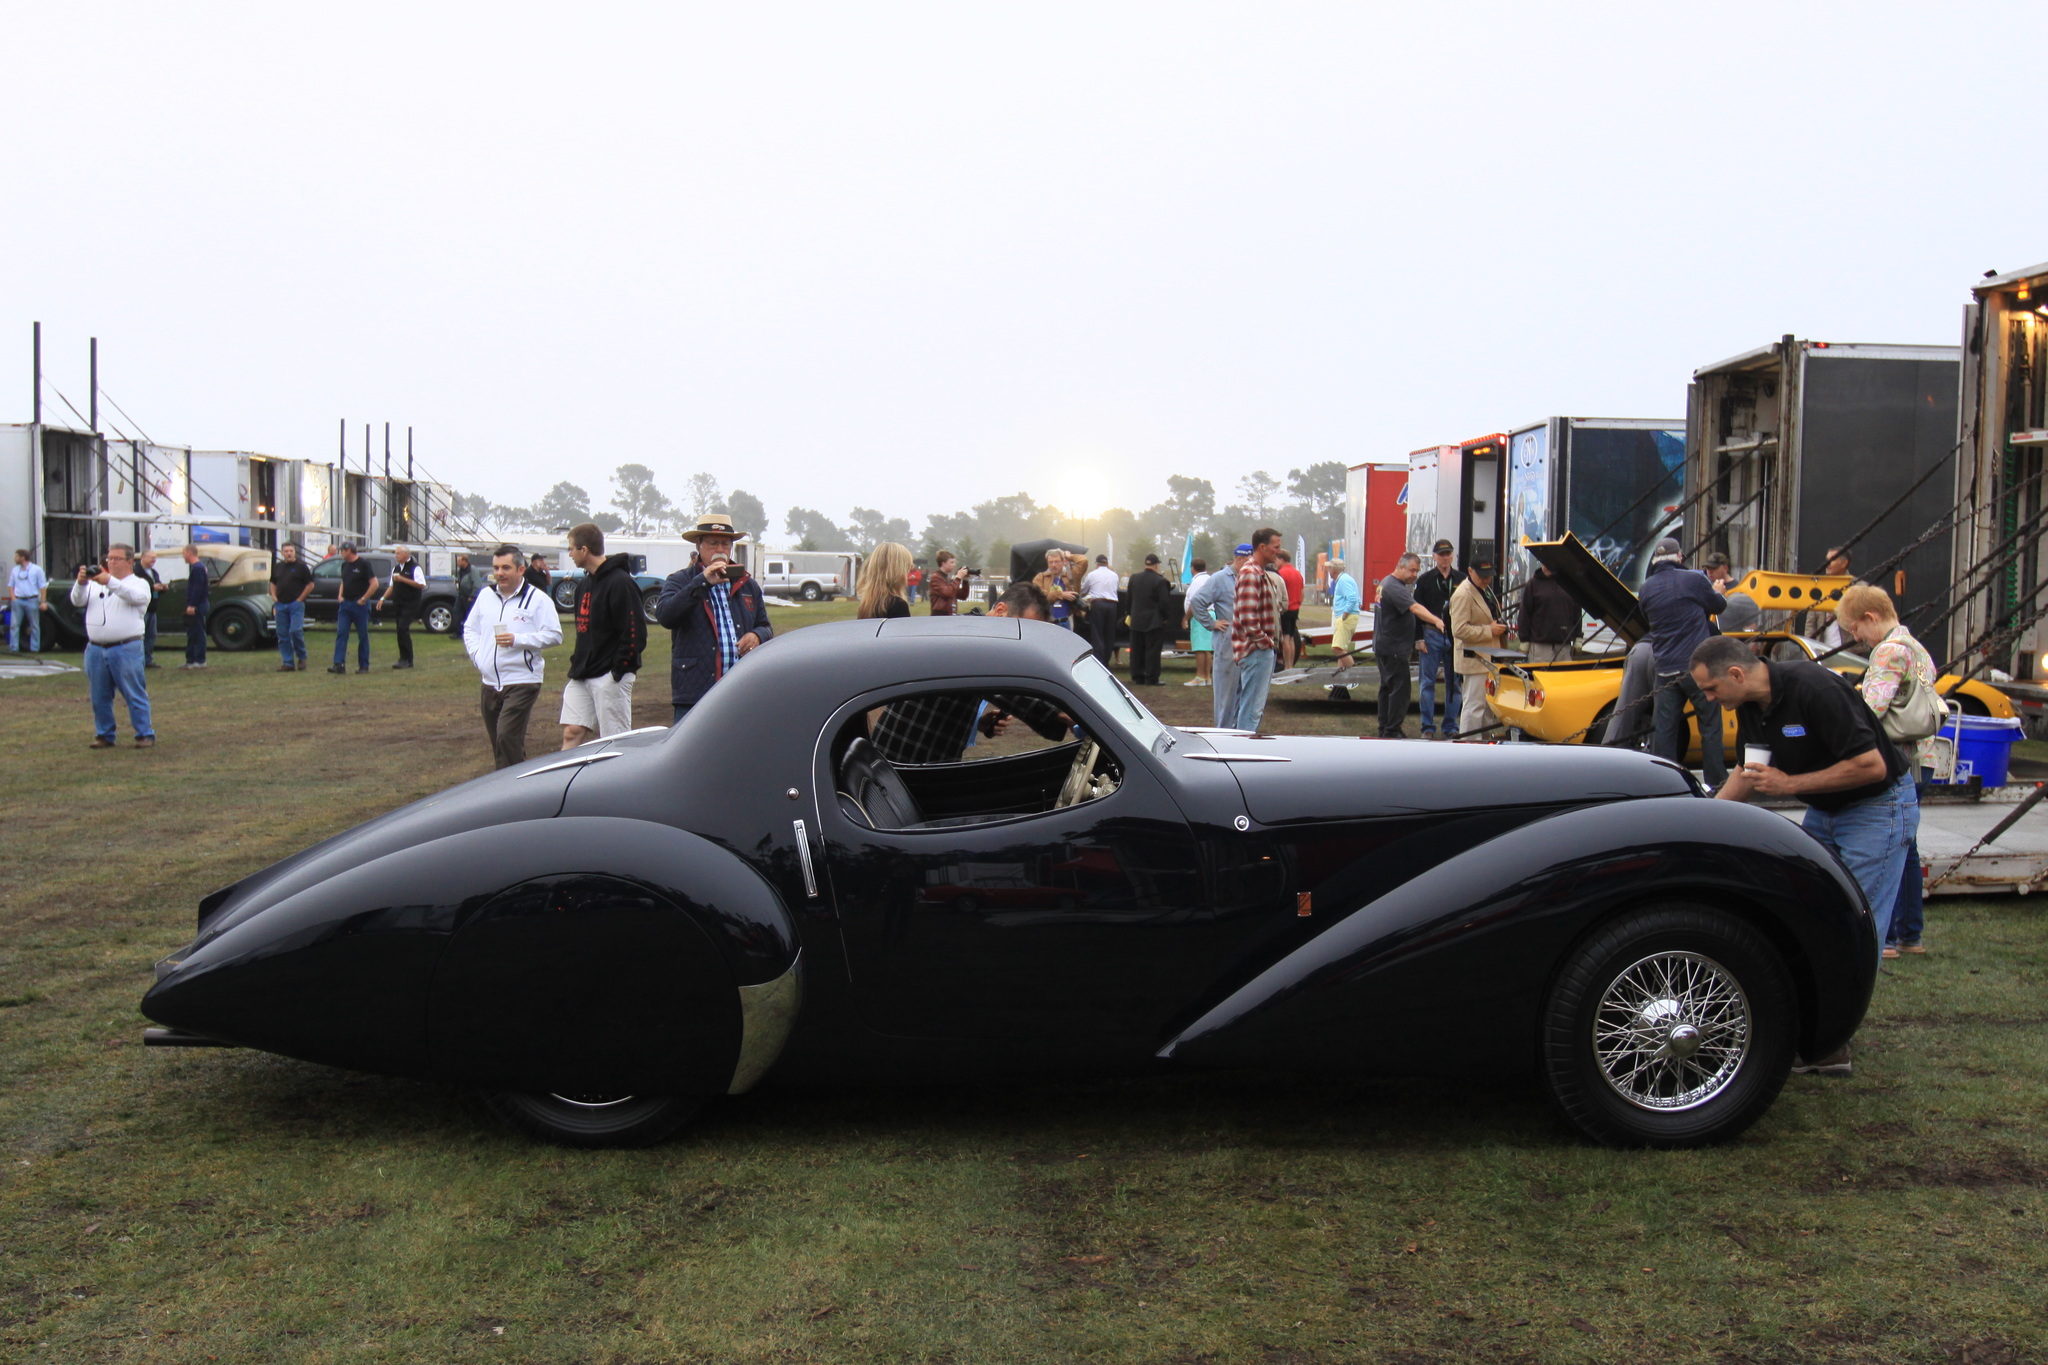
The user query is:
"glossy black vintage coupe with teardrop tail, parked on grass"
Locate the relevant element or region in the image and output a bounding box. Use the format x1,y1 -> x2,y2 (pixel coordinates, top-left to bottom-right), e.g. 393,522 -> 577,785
141,616 -> 1878,1146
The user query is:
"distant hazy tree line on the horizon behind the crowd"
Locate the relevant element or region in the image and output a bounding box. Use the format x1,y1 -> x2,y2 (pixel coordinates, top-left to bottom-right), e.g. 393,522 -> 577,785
455,460 -> 1346,573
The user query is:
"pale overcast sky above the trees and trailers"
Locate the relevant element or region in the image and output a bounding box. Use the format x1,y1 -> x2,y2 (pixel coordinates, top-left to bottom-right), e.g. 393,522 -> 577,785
0,0 -> 2048,532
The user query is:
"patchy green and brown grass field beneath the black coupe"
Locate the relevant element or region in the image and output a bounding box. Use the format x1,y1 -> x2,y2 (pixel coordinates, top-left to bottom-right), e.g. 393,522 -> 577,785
0,606 -> 2048,1365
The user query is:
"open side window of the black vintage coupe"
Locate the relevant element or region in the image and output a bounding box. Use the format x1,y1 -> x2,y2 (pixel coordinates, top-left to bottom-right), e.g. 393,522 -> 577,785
831,688 -> 1122,831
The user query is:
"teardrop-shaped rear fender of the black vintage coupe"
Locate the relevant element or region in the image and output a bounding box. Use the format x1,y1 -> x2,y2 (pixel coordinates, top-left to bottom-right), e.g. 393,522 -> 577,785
143,817 -> 797,1089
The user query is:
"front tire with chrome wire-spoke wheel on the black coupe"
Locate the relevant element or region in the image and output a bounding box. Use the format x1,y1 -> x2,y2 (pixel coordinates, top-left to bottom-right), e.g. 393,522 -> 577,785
1542,905 -> 1798,1148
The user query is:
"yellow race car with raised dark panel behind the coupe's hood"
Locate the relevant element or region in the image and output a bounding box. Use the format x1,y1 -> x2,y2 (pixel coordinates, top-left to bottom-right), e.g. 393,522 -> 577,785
1485,534 -> 2017,761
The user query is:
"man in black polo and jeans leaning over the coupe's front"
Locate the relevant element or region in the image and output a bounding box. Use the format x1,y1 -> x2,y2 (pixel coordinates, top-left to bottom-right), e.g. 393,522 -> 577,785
1692,634 -> 1919,1074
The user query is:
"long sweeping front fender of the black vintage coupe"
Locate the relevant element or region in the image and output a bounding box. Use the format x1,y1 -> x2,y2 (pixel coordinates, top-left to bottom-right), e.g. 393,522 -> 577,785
1159,798 -> 1876,1072
